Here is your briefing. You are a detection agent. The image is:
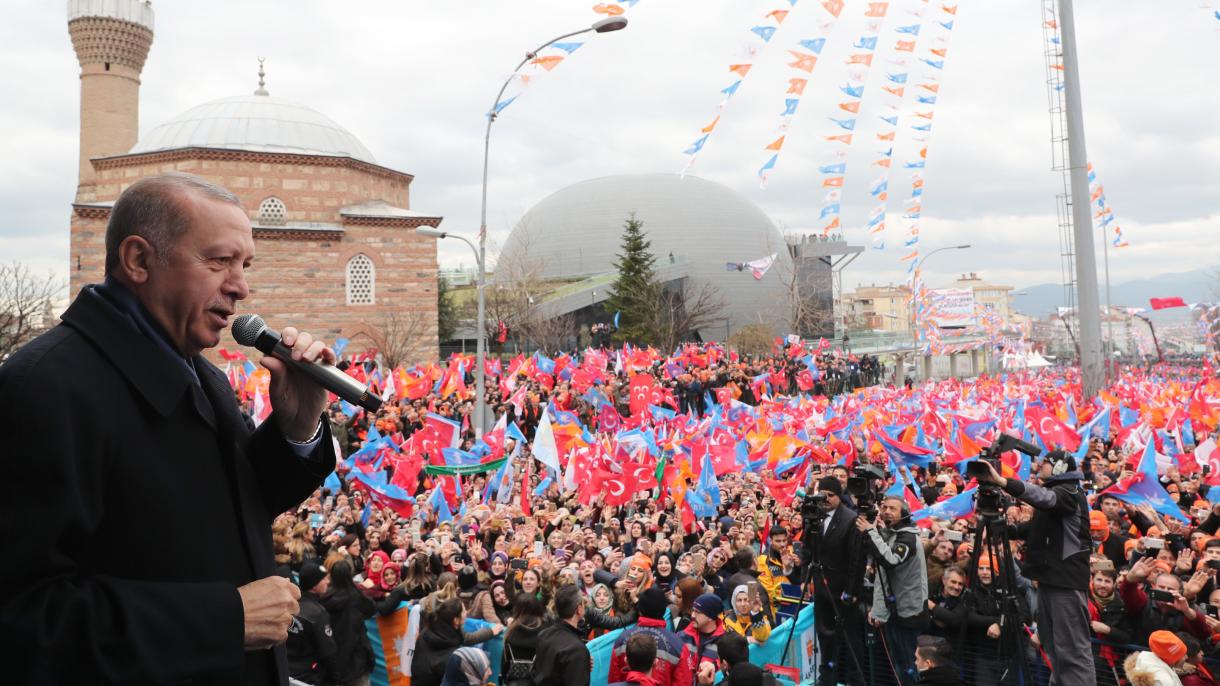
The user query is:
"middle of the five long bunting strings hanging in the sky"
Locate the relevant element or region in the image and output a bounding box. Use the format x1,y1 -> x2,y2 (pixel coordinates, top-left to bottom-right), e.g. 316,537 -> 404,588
817,2 -> 889,236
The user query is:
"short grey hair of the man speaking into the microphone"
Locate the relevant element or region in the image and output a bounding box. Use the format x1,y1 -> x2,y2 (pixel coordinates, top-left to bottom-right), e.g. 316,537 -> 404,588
106,172 -> 242,276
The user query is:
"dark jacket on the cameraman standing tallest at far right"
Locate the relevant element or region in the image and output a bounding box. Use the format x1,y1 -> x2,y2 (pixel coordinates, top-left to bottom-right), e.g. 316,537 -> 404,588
1004,470 -> 1093,591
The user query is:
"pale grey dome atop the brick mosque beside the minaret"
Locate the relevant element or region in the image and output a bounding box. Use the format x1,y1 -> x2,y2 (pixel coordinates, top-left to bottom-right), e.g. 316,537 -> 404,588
131,95 -> 377,164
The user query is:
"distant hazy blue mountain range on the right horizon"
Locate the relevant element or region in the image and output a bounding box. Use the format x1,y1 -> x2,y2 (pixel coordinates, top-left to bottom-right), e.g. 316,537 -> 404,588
1013,267 -> 1220,321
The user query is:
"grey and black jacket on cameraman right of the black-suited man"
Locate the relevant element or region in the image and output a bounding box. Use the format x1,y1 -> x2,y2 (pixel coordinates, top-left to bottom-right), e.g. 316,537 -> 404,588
864,519 -> 927,621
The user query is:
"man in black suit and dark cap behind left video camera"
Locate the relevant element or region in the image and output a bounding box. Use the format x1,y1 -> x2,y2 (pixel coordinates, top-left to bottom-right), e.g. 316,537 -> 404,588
809,476 -> 864,684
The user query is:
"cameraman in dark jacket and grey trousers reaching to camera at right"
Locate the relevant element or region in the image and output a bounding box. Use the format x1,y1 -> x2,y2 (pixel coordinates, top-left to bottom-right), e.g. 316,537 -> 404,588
977,450 -> 1097,686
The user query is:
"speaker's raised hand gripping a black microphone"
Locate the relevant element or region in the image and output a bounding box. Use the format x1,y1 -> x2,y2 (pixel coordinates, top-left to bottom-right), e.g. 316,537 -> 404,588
233,315 -> 381,441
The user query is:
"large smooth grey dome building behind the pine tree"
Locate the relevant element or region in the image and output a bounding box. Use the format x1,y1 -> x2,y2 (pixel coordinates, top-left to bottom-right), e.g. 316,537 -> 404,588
500,173 -> 793,339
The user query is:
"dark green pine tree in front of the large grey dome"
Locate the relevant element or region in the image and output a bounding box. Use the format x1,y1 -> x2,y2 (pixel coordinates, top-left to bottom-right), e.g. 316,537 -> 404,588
604,214 -> 658,344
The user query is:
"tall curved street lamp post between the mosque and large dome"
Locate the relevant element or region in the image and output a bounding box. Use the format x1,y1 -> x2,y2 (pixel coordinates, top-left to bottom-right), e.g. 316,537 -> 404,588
416,17 -> 627,438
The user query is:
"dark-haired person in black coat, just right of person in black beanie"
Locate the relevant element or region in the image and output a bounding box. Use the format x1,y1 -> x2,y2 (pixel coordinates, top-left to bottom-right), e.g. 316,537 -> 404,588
320,559 -> 373,686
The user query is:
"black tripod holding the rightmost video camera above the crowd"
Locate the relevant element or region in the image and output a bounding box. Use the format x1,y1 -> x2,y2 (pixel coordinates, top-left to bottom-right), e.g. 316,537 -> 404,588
958,505 -> 1030,684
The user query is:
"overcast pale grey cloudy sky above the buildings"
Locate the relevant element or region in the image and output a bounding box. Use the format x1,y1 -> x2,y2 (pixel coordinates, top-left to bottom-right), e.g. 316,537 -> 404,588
0,0 -> 1220,288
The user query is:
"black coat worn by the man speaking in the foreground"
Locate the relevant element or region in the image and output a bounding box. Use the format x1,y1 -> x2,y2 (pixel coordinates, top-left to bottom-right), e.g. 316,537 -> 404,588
0,287 -> 334,685
